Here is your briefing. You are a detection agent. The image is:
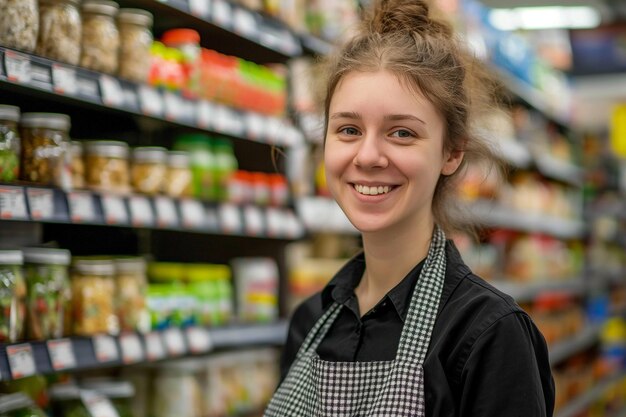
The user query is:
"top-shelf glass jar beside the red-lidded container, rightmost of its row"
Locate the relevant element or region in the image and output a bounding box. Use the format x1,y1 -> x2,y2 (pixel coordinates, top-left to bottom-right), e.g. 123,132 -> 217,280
117,9 -> 153,82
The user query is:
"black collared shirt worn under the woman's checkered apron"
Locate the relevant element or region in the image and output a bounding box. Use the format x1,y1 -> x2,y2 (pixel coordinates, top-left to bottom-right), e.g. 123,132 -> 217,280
281,242 -> 554,417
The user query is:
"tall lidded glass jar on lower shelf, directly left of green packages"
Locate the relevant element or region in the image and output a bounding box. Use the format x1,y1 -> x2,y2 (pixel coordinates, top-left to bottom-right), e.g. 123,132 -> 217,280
115,258 -> 150,332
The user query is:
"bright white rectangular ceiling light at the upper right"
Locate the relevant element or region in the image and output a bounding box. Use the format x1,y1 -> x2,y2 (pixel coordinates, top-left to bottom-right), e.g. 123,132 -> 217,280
489,6 -> 602,30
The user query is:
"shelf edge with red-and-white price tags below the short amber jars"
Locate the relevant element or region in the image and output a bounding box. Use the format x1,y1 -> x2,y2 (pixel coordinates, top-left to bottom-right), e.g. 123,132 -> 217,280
0,185 -> 304,240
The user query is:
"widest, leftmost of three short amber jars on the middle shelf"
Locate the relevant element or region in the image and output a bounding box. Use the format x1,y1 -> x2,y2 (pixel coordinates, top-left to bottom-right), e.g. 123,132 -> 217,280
85,140 -> 130,194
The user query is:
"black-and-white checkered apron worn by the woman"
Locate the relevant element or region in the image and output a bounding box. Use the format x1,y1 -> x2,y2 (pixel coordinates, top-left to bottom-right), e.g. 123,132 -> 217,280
264,226 -> 446,417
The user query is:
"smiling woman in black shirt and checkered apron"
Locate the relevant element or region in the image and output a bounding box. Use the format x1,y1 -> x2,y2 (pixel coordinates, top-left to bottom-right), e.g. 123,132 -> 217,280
265,0 -> 554,417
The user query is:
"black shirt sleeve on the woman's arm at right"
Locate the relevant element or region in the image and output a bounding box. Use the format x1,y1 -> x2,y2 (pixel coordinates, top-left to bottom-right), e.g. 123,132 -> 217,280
459,312 -> 554,417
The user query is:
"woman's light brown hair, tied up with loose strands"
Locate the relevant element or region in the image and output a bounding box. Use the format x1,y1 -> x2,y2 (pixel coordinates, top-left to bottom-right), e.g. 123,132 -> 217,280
324,0 -> 502,232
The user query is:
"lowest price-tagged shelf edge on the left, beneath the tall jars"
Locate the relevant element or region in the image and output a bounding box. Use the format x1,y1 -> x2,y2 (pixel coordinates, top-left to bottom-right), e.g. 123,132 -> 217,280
0,321 -> 287,381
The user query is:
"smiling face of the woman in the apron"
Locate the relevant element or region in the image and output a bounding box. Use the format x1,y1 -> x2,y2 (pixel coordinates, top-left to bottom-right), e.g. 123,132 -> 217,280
324,71 -> 463,233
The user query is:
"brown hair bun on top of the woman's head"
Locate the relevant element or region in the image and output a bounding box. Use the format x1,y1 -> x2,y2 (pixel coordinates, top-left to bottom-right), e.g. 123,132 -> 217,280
364,0 -> 452,37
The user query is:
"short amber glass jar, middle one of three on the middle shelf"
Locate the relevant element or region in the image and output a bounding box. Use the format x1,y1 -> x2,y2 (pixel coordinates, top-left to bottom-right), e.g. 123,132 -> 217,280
131,146 -> 167,195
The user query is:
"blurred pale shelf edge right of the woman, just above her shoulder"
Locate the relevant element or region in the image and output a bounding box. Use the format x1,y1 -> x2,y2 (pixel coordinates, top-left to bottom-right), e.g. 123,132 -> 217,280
468,200 -> 585,239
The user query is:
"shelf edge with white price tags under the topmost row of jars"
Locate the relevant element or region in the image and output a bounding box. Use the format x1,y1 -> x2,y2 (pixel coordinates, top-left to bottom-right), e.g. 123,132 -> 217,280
0,47 -> 304,146
